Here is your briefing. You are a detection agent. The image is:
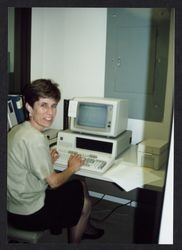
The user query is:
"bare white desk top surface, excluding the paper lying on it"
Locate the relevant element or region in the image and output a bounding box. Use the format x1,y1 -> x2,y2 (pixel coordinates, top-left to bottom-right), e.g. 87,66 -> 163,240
54,145 -> 165,190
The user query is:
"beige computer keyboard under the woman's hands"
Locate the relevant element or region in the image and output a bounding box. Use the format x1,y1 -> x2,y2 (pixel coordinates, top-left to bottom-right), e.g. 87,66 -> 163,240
55,148 -> 114,174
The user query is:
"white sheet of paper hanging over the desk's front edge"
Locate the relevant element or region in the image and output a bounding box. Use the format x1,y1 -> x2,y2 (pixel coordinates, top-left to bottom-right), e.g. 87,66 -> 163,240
103,161 -> 160,192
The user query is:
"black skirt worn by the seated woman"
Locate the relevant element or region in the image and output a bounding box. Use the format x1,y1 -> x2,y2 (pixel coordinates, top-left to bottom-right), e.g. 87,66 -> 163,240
8,180 -> 84,231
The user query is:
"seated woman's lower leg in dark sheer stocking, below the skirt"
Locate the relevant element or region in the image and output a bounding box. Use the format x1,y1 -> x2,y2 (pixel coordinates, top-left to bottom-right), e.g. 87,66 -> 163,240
68,182 -> 91,243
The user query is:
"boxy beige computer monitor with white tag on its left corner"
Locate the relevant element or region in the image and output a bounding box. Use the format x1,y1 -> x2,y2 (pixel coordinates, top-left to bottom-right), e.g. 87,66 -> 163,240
68,97 -> 128,137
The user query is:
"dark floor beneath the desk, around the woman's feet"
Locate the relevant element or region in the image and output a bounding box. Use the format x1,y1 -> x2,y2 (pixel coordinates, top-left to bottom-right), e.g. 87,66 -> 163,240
39,197 -> 134,245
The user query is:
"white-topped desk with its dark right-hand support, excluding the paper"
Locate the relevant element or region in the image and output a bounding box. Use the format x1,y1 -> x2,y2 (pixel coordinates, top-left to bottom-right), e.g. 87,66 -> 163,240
55,145 -> 165,244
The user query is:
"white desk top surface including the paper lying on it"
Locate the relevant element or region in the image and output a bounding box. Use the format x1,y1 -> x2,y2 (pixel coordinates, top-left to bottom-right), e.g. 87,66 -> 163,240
54,145 -> 165,191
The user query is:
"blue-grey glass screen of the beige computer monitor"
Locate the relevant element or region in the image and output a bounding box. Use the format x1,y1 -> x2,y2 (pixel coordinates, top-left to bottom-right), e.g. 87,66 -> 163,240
77,103 -> 107,128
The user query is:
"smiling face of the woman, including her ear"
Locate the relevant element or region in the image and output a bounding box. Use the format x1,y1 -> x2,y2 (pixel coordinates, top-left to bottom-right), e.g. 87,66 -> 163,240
26,97 -> 57,131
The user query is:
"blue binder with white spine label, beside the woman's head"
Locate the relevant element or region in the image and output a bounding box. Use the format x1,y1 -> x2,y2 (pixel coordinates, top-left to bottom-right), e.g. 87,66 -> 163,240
8,95 -> 25,123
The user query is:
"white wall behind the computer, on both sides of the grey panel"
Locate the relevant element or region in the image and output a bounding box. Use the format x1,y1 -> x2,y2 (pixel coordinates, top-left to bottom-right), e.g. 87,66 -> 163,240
31,8 -> 174,143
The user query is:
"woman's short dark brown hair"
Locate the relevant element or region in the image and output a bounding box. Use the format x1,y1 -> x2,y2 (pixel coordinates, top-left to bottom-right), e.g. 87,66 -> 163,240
23,79 -> 61,107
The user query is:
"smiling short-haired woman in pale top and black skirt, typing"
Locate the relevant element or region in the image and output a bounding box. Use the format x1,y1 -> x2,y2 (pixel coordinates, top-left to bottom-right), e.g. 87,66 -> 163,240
7,79 -> 104,243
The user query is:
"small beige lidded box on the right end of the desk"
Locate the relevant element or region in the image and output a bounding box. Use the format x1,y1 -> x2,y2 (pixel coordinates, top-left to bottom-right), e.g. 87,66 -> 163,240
137,139 -> 168,170
